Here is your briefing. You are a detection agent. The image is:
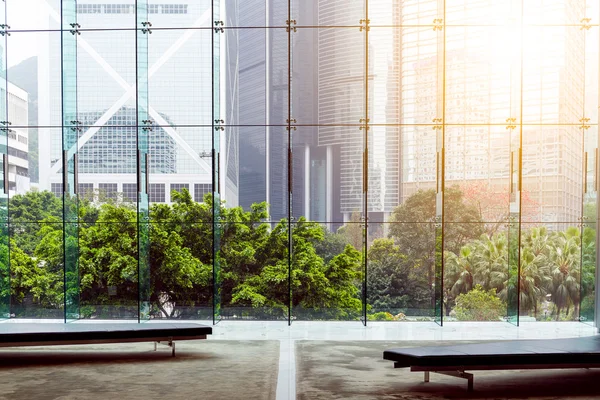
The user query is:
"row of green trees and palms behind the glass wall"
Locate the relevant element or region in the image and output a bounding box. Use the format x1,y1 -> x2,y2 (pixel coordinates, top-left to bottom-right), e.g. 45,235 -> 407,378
0,187 -> 596,320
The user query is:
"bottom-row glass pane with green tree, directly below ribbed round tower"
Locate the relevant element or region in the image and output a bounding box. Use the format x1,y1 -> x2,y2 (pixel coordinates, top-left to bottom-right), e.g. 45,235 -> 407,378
290,218 -> 365,320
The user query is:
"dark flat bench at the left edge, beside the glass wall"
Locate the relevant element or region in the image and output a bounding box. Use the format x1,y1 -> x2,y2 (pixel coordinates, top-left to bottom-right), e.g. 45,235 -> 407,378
0,322 -> 212,356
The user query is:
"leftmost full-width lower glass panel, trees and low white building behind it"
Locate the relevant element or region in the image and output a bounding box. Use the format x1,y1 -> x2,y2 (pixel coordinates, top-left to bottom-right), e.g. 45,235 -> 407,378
8,128 -> 65,319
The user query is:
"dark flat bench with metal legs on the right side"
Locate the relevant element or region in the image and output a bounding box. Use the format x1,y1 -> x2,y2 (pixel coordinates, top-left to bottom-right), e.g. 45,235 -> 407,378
383,336 -> 600,391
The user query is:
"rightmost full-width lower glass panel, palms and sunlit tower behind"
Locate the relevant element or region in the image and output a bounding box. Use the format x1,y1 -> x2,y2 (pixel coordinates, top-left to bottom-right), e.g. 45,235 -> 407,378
519,125 -> 590,321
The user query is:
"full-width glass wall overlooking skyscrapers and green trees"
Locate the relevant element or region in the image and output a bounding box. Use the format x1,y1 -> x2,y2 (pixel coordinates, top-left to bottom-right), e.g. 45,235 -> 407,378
0,0 -> 600,324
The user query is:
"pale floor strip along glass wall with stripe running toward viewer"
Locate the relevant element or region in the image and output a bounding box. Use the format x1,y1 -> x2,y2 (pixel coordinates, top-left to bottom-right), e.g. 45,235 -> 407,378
2,320 -> 597,400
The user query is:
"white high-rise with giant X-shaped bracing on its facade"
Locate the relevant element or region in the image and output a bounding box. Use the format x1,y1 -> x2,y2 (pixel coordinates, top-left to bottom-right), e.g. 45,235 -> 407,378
38,0 -> 238,206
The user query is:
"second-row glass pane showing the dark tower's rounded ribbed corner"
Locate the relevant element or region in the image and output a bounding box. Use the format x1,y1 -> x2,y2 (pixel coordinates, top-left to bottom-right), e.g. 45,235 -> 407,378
286,28 -> 366,126
